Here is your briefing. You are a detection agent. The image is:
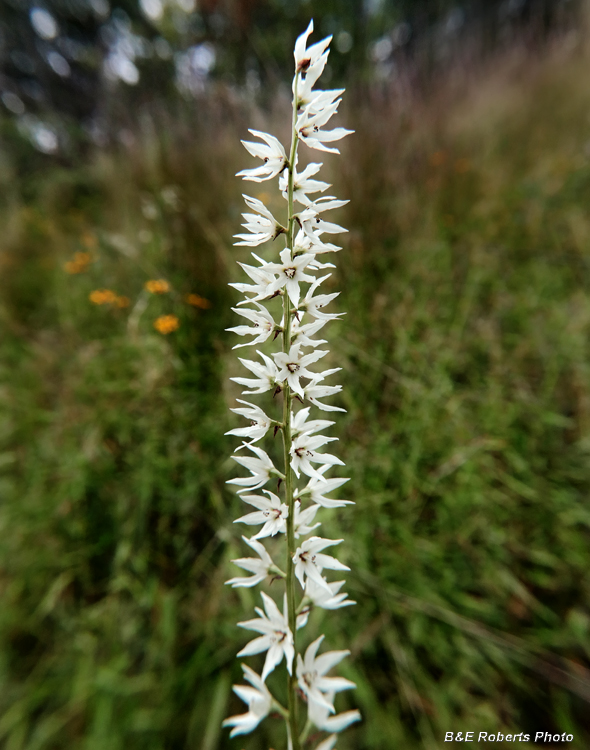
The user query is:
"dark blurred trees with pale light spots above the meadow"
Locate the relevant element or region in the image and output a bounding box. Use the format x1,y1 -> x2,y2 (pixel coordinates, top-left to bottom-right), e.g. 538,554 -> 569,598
0,0 -> 581,157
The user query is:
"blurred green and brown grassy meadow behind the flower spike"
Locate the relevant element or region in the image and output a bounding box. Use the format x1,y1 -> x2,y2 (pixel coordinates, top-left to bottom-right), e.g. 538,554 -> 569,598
0,39 -> 590,750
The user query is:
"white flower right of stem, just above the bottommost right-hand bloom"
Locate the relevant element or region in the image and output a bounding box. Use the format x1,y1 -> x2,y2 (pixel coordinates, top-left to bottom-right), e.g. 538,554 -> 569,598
297,635 -> 356,714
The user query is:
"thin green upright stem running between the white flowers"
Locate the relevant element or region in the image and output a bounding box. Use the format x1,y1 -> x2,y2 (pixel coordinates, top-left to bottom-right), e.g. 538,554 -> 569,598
283,74 -> 301,750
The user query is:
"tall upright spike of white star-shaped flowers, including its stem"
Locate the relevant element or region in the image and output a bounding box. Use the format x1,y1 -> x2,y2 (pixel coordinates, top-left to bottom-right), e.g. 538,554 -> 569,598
224,22 -> 360,750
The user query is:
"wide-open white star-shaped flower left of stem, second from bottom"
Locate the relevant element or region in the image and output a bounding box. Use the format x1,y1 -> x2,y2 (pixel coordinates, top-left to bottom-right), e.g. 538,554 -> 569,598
238,592 -> 295,682
